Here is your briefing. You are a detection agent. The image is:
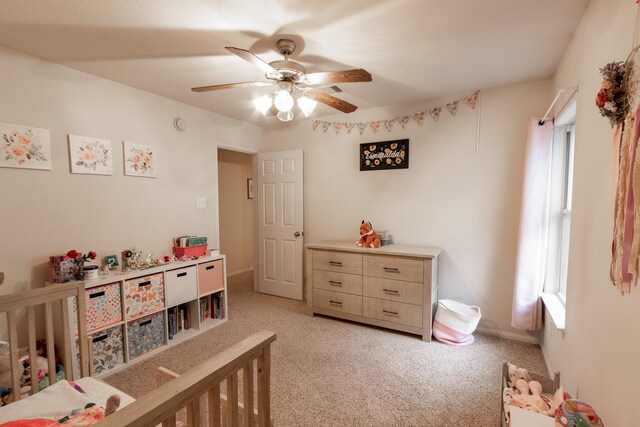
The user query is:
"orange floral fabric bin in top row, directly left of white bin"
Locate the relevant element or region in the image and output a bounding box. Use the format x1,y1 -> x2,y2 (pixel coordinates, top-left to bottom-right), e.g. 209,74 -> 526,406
124,273 -> 164,320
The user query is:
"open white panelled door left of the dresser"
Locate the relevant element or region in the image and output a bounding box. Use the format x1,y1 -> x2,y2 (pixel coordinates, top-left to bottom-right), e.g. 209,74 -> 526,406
257,150 -> 304,300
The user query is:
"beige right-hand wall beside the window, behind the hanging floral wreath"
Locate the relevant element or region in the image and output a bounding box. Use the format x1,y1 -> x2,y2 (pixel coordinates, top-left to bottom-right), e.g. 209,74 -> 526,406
543,0 -> 640,426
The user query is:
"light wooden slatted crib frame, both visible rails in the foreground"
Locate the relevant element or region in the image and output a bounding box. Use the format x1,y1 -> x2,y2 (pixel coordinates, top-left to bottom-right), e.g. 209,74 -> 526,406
0,282 -> 276,427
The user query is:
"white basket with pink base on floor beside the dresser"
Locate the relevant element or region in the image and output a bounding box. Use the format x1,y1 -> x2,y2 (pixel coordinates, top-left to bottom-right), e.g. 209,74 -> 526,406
433,299 -> 482,345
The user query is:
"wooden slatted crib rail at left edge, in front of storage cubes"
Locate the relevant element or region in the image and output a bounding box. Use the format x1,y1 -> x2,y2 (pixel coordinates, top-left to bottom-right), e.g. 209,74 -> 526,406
0,282 -> 89,401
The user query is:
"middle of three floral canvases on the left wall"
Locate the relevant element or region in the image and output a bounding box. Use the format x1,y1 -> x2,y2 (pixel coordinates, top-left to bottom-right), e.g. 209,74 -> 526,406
69,135 -> 113,175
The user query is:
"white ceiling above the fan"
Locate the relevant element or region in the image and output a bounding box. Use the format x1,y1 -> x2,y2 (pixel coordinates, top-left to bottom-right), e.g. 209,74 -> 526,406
0,0 -> 590,125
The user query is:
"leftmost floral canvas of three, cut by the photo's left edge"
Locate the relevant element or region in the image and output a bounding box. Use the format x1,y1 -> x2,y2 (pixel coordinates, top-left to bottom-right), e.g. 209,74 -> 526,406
0,123 -> 51,170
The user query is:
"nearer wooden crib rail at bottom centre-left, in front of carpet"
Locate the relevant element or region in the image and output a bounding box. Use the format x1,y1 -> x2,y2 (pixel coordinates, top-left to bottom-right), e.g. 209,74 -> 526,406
103,331 -> 276,427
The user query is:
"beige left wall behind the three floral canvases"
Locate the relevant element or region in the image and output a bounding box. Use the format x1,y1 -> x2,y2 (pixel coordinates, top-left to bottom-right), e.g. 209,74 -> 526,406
0,48 -> 261,300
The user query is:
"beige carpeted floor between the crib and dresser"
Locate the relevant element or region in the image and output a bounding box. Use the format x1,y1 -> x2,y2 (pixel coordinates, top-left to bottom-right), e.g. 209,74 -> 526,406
105,282 -> 546,427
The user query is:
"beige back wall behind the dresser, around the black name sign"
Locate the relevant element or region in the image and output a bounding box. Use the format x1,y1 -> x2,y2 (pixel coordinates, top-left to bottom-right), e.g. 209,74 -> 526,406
262,80 -> 551,341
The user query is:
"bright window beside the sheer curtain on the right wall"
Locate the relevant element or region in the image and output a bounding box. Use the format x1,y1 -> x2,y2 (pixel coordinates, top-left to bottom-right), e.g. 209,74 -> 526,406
545,101 -> 576,305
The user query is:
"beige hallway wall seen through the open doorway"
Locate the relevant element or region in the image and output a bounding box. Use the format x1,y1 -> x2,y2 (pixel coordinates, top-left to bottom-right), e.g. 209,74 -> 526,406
218,149 -> 255,274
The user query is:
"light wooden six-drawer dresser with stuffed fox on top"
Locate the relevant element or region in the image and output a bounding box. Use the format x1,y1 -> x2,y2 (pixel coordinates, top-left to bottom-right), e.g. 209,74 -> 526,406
305,241 -> 440,341
